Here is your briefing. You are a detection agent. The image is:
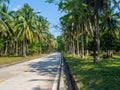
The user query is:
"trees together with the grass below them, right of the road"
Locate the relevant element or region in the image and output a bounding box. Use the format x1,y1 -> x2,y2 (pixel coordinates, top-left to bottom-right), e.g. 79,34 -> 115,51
47,0 -> 120,90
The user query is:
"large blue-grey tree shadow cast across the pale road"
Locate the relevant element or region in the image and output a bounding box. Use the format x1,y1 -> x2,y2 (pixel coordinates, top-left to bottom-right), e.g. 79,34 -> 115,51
29,55 -> 60,76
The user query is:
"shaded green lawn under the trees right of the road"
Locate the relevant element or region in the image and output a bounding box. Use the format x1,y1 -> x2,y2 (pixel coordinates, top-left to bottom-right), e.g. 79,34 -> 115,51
65,55 -> 120,90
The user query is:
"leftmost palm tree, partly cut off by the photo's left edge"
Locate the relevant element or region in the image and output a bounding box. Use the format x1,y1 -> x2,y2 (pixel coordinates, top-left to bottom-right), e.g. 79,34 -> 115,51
0,4 -> 14,55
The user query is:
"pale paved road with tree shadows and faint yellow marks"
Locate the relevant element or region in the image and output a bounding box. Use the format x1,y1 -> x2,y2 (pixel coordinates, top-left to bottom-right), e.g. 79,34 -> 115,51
0,53 -> 61,90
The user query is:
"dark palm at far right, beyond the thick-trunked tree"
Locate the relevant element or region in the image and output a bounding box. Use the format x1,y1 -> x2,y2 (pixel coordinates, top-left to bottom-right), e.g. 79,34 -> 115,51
101,7 -> 120,57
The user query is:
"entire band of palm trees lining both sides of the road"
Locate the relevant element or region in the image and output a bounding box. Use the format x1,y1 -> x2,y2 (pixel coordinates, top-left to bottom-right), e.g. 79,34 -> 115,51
0,0 -> 120,62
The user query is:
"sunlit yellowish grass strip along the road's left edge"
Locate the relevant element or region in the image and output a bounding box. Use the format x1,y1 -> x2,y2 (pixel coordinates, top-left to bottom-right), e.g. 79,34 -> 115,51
0,54 -> 47,65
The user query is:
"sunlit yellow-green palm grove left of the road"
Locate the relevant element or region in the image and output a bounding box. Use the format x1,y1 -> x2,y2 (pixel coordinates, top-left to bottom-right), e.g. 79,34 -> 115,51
0,0 -> 57,57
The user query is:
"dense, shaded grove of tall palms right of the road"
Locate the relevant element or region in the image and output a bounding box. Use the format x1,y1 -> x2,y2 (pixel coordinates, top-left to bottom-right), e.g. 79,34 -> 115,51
52,0 -> 120,62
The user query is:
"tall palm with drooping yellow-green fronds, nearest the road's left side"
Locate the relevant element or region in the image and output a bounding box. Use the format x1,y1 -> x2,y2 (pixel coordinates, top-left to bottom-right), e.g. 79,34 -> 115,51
15,4 -> 38,58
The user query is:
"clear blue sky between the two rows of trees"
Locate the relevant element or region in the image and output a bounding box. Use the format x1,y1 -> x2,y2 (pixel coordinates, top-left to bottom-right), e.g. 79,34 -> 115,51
9,0 -> 62,37
